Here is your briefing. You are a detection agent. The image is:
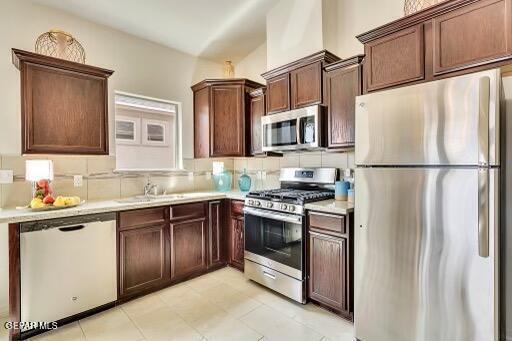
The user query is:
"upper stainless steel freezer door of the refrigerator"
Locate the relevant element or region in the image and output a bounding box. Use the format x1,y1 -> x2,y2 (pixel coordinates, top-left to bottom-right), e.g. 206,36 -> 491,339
355,70 -> 500,165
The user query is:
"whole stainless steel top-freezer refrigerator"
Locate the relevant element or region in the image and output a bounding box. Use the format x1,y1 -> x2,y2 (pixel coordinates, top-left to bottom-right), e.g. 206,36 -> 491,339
354,70 -> 502,341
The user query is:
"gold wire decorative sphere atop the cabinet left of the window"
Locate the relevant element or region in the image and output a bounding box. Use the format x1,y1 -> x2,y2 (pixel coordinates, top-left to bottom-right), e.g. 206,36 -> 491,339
36,30 -> 85,63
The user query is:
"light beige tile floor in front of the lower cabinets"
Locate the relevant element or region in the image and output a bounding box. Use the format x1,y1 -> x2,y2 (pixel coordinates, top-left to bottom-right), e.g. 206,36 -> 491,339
18,268 -> 354,341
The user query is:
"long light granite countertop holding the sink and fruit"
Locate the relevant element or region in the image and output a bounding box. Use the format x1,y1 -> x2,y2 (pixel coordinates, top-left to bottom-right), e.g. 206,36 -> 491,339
0,192 -> 246,224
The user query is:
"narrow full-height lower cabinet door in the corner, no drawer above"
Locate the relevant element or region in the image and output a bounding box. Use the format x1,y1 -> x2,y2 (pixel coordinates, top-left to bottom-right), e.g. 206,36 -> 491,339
208,201 -> 225,267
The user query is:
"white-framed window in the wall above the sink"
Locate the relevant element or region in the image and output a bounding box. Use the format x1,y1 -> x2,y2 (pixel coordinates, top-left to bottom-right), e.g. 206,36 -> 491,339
115,92 -> 182,171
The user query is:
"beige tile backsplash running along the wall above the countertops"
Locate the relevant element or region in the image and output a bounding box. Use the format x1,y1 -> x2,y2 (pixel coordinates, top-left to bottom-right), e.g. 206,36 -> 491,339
0,152 -> 354,207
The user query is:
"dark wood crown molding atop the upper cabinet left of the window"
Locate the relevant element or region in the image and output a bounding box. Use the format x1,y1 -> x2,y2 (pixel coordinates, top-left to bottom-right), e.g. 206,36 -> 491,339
12,48 -> 114,78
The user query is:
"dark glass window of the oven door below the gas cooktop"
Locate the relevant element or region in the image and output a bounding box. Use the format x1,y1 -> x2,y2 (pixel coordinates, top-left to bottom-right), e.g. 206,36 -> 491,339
245,214 -> 303,270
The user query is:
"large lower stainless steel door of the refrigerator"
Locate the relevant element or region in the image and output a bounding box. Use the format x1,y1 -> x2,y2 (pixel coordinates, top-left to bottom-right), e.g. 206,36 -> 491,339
354,168 -> 498,341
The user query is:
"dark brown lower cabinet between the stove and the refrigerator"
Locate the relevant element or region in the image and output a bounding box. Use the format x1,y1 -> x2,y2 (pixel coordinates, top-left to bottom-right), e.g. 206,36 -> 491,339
307,212 -> 353,321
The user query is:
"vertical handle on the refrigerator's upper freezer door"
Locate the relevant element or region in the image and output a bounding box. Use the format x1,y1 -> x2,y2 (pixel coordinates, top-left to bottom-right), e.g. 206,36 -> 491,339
478,76 -> 491,166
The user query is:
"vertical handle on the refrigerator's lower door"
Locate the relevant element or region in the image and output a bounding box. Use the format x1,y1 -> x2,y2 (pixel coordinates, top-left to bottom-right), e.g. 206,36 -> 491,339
478,168 -> 489,258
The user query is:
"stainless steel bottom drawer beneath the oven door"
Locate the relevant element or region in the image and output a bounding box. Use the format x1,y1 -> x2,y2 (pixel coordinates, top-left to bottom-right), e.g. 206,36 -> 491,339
244,259 -> 306,304
